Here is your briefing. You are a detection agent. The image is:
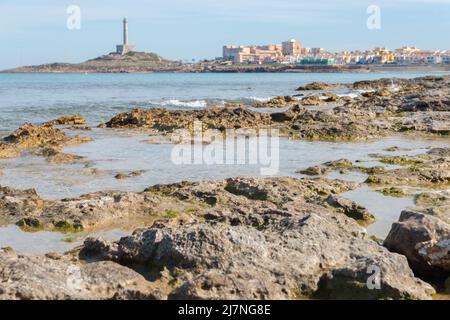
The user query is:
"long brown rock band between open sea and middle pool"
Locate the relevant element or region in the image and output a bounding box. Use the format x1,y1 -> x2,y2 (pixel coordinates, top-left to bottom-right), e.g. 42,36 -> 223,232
104,76 -> 450,141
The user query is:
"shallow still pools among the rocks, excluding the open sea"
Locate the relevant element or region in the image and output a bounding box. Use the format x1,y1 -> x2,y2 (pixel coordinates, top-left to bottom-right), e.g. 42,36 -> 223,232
0,129 -> 450,253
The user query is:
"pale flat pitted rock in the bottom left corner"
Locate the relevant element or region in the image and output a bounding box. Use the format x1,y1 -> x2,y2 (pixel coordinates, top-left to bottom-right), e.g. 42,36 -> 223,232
0,249 -> 155,300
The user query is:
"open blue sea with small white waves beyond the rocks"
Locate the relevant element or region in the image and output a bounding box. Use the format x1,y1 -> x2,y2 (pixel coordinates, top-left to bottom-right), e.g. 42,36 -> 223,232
0,73 -> 442,132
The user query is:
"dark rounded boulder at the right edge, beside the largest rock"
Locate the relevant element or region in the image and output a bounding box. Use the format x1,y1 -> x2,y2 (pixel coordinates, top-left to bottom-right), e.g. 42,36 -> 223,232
384,210 -> 450,276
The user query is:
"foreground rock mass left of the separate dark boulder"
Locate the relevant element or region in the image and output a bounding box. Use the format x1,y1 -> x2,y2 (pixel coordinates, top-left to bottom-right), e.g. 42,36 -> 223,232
0,178 -> 434,299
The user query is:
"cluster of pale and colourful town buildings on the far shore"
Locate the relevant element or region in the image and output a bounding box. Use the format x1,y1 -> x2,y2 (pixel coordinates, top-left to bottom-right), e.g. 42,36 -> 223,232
222,39 -> 450,65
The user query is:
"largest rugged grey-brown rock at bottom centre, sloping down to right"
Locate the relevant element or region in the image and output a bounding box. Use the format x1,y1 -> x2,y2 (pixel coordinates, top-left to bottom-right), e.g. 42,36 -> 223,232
81,211 -> 434,299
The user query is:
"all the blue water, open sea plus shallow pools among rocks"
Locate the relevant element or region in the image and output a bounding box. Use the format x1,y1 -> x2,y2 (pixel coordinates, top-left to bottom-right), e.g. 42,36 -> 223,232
0,73 -> 450,253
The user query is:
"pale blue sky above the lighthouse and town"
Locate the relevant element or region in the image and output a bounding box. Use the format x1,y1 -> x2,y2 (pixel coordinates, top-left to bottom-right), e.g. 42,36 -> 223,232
0,0 -> 450,69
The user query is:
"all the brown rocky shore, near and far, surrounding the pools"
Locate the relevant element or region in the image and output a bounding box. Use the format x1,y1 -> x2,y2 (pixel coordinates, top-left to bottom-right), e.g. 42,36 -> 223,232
0,77 -> 450,299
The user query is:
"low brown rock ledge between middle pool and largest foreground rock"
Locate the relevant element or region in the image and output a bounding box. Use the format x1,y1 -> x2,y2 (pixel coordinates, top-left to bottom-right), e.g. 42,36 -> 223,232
0,178 -> 356,232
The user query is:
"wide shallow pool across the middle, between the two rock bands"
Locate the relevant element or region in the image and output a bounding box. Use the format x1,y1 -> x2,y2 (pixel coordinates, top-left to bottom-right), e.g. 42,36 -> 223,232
0,129 -> 450,199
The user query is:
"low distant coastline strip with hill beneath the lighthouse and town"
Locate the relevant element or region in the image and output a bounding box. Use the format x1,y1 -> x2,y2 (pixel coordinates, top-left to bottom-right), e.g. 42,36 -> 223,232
0,52 -> 450,74
